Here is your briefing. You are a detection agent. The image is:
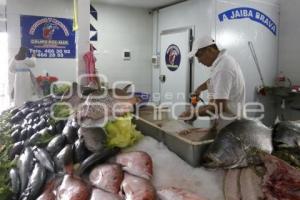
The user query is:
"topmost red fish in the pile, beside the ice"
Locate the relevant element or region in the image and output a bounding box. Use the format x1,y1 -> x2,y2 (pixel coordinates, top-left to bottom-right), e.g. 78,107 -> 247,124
116,151 -> 153,179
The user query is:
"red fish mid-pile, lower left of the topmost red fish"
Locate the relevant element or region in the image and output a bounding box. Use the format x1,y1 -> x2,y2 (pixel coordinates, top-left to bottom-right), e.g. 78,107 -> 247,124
89,164 -> 124,194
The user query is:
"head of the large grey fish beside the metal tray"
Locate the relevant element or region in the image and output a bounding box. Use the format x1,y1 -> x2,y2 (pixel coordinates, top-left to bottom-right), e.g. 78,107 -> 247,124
203,132 -> 246,168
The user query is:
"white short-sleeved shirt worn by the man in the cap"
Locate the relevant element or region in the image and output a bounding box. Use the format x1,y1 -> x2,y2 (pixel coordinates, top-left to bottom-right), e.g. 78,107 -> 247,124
208,50 -> 245,119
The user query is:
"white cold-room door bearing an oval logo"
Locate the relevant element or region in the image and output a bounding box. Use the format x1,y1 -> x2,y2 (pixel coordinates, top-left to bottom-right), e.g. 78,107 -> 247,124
160,28 -> 192,114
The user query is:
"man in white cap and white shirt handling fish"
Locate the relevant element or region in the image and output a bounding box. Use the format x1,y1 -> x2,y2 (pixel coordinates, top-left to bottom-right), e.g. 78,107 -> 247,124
180,36 -> 245,130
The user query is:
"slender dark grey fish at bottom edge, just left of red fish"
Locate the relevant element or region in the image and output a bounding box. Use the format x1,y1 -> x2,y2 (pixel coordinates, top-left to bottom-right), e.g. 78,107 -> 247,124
20,163 -> 47,200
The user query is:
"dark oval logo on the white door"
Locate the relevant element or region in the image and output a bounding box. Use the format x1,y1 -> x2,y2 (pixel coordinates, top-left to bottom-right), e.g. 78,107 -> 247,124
166,44 -> 181,71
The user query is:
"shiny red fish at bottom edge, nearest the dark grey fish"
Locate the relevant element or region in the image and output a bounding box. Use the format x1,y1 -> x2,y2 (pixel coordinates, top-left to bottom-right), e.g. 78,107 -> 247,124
57,175 -> 91,200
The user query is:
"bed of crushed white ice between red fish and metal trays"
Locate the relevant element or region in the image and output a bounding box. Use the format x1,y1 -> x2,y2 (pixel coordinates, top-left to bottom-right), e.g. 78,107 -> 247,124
125,136 -> 224,200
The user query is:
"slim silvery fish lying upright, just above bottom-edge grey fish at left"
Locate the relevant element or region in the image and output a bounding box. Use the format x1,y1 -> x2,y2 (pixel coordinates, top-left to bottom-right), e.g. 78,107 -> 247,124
18,147 -> 33,192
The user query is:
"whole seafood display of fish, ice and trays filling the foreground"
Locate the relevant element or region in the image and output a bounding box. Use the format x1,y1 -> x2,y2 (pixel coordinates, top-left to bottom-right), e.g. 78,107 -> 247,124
0,85 -> 300,200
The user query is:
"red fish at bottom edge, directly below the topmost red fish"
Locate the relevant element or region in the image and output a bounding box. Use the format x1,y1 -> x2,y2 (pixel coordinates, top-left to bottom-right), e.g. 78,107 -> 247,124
121,173 -> 157,200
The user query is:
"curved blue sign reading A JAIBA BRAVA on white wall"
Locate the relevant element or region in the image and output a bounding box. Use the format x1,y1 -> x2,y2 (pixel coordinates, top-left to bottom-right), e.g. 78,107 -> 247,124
219,7 -> 277,35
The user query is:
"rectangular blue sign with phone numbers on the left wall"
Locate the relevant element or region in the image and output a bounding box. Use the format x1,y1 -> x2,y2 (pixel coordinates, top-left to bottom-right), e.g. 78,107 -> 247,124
21,15 -> 76,58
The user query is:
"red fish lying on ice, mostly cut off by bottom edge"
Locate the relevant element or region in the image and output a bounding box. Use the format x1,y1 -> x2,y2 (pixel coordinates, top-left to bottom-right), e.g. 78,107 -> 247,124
157,187 -> 209,200
